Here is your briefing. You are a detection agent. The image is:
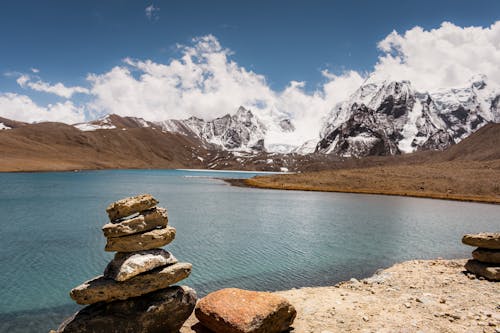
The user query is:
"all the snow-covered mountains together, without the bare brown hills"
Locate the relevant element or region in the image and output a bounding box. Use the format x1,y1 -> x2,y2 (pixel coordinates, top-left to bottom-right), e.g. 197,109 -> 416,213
72,76 -> 500,157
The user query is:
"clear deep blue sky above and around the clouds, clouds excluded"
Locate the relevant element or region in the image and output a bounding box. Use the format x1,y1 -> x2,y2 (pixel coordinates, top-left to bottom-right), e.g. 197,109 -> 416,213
0,0 -> 500,124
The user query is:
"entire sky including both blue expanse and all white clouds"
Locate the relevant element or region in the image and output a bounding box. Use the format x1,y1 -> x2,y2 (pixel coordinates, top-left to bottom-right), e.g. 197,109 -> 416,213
0,0 -> 500,134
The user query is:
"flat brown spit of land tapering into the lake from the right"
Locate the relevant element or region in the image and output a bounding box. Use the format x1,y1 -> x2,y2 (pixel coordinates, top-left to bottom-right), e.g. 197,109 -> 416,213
226,160 -> 500,204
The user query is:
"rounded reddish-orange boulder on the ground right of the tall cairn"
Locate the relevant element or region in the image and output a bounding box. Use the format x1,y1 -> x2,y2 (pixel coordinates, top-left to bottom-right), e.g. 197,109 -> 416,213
195,288 -> 296,333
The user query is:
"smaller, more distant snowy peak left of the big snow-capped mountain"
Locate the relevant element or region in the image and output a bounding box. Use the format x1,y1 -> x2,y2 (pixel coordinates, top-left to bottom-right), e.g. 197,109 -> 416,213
157,107 -> 270,151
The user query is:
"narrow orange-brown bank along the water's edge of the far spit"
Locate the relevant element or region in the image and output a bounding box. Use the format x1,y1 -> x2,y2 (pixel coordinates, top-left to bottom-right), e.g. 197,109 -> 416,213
227,178 -> 500,205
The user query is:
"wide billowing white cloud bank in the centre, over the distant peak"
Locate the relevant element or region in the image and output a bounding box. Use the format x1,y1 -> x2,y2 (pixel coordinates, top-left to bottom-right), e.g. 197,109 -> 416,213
88,35 -> 363,144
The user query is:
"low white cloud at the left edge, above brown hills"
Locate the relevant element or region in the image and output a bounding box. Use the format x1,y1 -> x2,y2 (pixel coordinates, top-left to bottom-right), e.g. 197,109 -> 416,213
0,93 -> 85,124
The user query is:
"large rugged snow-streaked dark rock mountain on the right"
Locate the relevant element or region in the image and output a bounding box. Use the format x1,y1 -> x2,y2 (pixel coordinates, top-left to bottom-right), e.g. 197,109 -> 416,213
316,77 -> 500,157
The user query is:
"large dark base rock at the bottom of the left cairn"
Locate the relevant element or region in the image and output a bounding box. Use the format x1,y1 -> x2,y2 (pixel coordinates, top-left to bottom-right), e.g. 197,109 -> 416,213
57,286 -> 196,333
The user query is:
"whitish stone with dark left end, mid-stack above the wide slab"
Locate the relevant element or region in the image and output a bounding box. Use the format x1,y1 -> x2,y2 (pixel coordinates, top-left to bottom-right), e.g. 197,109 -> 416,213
104,249 -> 177,281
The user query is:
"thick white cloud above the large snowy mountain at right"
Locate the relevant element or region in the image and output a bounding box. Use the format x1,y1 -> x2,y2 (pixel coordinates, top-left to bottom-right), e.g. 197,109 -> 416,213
372,21 -> 500,90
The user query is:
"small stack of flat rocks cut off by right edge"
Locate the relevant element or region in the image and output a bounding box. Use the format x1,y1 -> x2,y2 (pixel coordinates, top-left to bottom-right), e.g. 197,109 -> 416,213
462,232 -> 500,281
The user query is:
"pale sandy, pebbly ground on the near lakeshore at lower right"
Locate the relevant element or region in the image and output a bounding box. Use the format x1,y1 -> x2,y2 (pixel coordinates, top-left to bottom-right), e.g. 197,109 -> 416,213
181,260 -> 500,333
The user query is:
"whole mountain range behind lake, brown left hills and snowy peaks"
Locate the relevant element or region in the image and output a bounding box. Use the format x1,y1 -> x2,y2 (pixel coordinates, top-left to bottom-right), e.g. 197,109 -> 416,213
0,76 -> 500,171
